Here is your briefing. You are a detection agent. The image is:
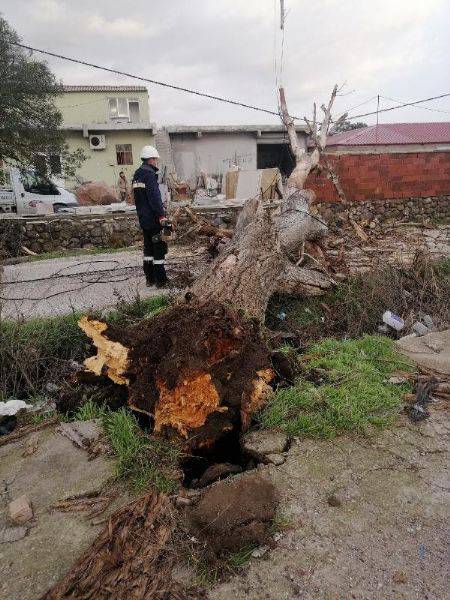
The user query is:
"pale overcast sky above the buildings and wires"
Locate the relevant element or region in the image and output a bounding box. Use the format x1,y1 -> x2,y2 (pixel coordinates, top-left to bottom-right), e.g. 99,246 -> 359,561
0,0 -> 450,125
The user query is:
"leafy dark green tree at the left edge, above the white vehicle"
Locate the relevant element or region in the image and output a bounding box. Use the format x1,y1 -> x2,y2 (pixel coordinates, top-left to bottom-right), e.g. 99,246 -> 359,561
0,16 -> 86,177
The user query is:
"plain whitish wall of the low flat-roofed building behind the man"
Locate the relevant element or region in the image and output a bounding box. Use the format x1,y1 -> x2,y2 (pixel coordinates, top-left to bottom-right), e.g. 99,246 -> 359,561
170,133 -> 257,184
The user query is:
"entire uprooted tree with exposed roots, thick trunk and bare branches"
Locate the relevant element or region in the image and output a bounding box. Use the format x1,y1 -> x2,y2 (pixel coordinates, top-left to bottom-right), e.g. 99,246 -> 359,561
80,87 -> 337,450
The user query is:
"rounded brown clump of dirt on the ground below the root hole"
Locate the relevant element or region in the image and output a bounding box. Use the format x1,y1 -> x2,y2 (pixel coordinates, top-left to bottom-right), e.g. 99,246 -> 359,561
188,473 -> 278,554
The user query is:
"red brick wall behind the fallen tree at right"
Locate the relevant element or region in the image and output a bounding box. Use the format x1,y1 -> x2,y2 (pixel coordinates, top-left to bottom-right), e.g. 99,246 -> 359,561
305,152 -> 450,202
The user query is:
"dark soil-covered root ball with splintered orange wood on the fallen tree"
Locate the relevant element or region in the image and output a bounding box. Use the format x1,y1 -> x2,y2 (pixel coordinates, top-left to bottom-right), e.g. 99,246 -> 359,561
80,301 -> 274,449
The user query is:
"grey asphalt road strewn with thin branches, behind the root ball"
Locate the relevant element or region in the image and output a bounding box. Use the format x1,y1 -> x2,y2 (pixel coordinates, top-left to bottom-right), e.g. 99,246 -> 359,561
0,248 -> 199,319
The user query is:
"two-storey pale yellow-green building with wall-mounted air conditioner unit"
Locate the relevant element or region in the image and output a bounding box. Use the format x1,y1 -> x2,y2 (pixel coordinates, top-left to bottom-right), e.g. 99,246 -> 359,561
57,85 -> 154,187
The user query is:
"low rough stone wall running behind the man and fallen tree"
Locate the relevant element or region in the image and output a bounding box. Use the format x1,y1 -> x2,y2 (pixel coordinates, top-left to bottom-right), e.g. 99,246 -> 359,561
0,196 -> 450,257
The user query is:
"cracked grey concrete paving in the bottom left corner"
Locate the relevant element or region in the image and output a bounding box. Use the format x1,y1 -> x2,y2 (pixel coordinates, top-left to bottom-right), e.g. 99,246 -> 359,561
0,427 -> 118,600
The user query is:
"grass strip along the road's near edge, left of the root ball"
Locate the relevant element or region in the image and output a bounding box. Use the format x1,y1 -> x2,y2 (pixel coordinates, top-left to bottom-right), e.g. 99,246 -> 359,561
0,296 -> 169,400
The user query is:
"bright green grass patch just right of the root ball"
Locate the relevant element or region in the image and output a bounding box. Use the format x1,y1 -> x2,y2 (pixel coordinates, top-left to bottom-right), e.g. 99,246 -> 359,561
260,336 -> 412,438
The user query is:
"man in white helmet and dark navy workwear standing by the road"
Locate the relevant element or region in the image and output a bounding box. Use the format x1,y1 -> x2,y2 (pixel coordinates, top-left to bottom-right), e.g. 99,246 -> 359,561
132,146 -> 169,287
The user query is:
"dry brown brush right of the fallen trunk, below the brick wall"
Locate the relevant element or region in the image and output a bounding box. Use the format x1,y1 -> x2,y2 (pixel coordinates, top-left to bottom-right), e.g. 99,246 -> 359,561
267,255 -> 450,343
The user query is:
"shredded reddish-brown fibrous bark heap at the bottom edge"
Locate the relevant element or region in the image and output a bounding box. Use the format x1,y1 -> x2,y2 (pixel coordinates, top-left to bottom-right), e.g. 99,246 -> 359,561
41,493 -> 201,600
